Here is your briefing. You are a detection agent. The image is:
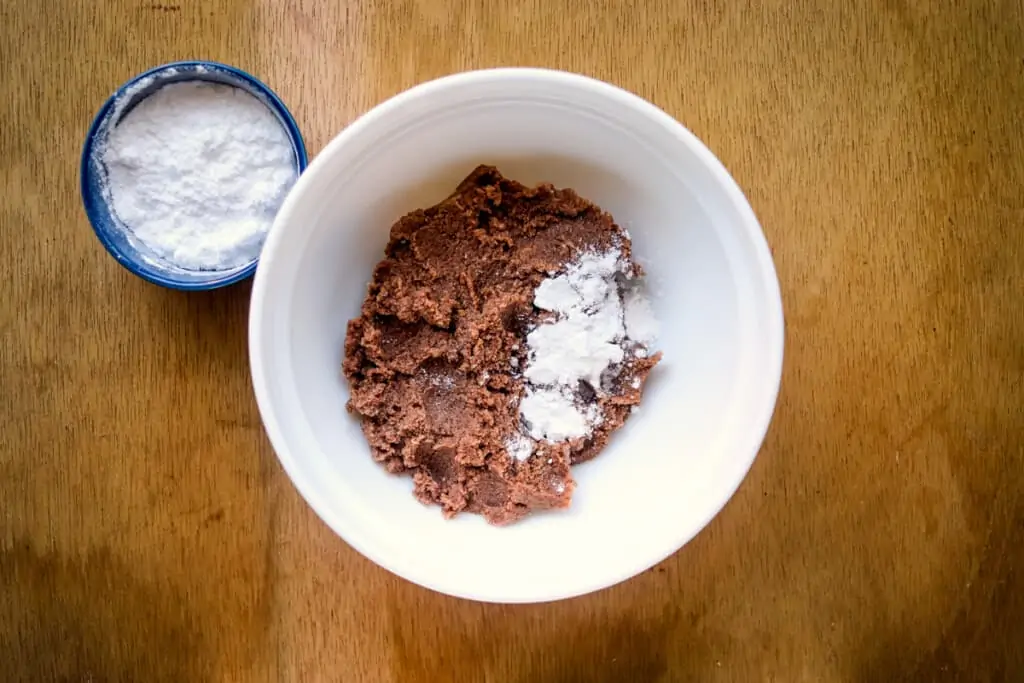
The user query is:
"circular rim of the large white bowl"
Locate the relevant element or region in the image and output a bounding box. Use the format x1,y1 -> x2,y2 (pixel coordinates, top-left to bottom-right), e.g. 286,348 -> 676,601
249,67 -> 785,603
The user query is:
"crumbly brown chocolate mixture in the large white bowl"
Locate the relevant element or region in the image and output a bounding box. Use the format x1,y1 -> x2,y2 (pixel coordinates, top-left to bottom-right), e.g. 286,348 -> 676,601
344,166 -> 659,524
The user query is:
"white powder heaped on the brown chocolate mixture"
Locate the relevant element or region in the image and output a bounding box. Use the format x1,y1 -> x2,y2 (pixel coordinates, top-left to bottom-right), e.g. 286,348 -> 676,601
519,249 -> 655,441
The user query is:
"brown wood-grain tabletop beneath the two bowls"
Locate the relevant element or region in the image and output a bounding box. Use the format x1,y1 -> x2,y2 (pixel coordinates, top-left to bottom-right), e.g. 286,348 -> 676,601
0,0 -> 1024,683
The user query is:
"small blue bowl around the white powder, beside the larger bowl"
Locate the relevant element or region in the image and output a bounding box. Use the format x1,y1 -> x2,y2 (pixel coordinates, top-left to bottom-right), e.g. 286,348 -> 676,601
81,61 -> 307,291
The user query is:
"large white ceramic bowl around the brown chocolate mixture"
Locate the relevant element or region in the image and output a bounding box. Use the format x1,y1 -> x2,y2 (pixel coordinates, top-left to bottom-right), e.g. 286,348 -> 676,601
249,69 -> 782,602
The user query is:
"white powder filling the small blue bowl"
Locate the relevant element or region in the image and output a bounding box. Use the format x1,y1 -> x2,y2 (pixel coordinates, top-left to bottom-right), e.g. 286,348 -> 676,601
99,81 -> 297,270
